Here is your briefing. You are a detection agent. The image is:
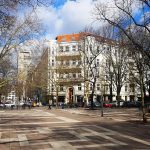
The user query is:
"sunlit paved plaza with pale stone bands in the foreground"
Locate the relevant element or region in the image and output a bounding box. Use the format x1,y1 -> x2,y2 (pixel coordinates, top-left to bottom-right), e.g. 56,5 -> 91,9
0,108 -> 150,150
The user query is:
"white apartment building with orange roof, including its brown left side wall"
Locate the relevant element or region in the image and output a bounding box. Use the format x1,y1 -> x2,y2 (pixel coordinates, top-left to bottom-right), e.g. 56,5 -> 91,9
24,33 -> 148,104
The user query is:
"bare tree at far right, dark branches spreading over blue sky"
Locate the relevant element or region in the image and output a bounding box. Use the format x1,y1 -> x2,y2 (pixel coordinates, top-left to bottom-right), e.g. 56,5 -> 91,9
95,0 -> 150,121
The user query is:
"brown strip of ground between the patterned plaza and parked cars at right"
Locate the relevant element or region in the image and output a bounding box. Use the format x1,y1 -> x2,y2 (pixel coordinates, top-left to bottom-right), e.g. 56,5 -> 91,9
61,108 -> 150,122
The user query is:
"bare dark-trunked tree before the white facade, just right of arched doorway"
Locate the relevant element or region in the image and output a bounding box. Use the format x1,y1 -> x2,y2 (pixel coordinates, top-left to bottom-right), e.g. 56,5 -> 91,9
79,30 -> 105,109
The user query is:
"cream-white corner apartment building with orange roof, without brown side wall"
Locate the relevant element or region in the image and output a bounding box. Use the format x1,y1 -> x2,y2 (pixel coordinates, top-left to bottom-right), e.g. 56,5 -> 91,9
47,33 -> 145,103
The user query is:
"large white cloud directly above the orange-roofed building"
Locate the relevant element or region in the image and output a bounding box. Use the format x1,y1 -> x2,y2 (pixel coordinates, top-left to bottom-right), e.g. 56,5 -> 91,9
34,0 -> 101,38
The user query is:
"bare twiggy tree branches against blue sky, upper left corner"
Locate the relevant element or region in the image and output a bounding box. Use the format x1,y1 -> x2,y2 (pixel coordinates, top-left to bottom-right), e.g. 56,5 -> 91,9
0,0 -> 52,60
